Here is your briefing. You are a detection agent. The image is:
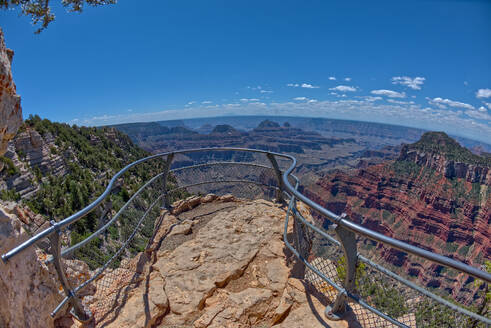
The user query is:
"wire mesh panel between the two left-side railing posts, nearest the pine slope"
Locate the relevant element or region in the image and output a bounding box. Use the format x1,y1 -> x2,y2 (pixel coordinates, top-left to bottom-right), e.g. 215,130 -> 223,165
64,168 -> 163,322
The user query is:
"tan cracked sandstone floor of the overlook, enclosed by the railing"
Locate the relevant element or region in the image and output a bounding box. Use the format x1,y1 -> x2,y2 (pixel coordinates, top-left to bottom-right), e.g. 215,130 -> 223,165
153,196 -> 302,327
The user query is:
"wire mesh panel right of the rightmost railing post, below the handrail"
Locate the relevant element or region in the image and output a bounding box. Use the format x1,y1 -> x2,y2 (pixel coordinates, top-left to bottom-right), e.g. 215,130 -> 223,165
357,241 -> 490,327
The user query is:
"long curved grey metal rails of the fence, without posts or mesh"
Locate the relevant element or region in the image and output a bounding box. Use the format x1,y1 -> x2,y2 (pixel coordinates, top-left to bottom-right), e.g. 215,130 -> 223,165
1,147 -> 491,327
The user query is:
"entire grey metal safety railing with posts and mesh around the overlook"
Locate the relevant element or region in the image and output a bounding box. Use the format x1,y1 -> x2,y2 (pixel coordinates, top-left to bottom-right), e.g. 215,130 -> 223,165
2,147 -> 491,327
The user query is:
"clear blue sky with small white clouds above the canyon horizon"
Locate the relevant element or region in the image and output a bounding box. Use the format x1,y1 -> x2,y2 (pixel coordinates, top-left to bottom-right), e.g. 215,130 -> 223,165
0,0 -> 491,142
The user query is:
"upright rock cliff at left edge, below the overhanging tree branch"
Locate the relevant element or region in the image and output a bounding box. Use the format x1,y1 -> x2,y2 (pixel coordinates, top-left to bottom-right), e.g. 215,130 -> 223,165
0,28 -> 22,167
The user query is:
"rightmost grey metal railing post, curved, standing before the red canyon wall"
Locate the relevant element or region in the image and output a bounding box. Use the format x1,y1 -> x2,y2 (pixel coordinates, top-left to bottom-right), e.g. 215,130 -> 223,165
324,213 -> 358,320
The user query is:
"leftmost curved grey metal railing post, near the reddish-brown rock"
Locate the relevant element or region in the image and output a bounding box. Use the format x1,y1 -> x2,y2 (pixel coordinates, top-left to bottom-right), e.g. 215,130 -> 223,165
48,221 -> 92,323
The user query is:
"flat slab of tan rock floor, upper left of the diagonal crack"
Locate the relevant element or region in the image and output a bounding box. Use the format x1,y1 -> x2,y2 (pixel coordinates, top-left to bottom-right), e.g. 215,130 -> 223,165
154,201 -> 284,323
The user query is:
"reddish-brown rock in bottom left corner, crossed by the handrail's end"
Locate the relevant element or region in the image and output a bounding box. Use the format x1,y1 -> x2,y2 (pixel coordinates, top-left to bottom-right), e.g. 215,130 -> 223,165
0,203 -> 63,327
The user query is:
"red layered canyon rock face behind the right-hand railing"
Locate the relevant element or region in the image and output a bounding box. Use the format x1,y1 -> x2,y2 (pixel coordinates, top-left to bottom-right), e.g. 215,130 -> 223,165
306,132 -> 491,302
